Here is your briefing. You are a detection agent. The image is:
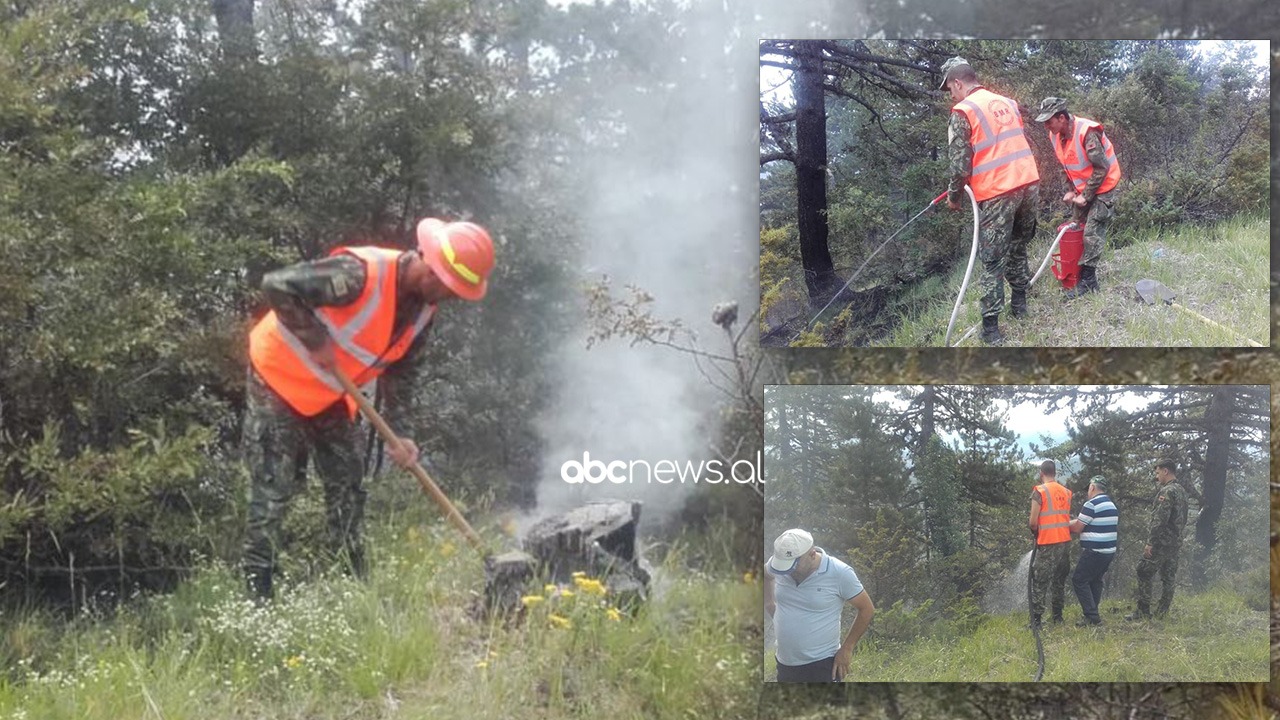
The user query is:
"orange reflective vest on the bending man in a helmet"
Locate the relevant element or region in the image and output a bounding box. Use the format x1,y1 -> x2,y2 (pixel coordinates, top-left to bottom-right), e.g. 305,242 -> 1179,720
248,247 -> 435,418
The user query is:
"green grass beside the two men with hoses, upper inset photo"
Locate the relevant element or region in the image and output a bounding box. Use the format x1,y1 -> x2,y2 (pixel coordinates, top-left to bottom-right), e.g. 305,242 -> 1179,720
877,211 -> 1271,347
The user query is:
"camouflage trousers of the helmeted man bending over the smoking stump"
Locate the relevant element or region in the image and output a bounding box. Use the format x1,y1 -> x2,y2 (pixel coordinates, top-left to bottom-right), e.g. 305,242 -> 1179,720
242,368 -> 365,575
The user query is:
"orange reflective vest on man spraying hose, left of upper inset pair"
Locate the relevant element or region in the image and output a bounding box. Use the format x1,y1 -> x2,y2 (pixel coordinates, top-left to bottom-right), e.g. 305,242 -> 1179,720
951,87 -> 1039,202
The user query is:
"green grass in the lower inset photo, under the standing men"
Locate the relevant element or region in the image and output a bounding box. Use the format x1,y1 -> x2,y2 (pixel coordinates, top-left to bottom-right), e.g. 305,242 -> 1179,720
765,588 -> 1271,683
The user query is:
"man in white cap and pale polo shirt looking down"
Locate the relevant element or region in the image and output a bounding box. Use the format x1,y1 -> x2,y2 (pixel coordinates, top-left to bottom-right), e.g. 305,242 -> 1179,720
764,529 -> 876,683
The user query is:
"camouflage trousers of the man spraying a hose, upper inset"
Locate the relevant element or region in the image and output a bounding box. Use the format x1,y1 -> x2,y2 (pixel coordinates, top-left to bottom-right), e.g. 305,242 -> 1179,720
978,183 -> 1039,318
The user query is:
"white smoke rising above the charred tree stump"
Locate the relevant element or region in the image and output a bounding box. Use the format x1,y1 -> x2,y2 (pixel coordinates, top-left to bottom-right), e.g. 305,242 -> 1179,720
527,0 -> 858,521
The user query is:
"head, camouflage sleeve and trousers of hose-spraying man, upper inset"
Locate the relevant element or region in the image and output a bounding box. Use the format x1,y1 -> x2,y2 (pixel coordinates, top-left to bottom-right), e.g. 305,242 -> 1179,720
942,58 -> 1039,345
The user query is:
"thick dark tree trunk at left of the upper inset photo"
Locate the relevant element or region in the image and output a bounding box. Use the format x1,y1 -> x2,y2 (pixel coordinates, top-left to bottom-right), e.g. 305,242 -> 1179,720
795,40 -> 836,304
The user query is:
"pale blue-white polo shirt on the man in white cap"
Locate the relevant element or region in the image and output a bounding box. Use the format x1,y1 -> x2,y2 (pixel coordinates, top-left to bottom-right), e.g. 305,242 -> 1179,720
765,547 -> 863,665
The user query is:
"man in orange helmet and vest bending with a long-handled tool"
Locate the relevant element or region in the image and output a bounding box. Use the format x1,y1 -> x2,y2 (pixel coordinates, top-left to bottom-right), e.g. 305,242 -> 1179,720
242,219 -> 493,598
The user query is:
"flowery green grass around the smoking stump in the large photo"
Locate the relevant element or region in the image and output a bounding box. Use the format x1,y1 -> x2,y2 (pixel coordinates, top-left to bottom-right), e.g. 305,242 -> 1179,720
0,509 -> 760,720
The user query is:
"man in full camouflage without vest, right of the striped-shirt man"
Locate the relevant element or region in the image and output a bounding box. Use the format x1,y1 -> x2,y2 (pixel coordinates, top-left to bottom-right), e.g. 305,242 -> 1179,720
1125,460 -> 1188,620
